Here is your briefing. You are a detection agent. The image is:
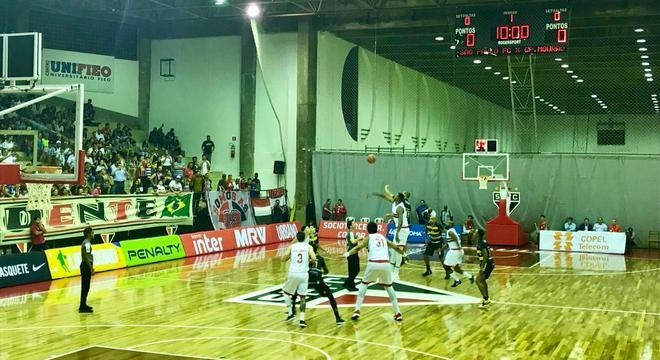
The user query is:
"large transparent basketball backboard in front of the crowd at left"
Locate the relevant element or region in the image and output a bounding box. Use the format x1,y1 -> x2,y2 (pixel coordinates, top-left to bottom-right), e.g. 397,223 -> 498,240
0,84 -> 85,184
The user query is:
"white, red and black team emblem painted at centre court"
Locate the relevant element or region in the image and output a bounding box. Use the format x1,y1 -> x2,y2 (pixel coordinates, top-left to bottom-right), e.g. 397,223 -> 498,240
225,275 -> 481,308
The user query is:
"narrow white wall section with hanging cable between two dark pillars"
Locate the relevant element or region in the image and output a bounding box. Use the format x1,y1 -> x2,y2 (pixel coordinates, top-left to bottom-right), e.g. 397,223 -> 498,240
254,33 -> 298,200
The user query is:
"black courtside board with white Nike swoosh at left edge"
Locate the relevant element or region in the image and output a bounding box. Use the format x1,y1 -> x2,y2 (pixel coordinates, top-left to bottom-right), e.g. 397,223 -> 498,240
0,252 -> 50,288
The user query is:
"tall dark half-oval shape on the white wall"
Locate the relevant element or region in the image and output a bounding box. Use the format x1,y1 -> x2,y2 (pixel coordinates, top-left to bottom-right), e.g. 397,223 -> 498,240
341,46 -> 358,141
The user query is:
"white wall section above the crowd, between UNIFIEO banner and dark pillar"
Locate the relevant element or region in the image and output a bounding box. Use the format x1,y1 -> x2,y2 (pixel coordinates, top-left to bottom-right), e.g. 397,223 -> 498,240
149,36 -> 241,176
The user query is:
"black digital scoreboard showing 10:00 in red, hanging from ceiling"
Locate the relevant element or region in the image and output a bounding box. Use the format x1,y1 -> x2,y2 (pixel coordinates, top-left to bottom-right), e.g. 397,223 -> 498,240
454,4 -> 569,56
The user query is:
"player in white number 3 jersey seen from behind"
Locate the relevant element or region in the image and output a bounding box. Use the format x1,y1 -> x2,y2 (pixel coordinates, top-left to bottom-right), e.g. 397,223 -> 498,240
282,231 -> 316,328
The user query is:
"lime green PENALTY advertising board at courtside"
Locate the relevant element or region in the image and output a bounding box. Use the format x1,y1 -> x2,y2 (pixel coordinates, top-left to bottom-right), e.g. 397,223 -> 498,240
119,235 -> 186,266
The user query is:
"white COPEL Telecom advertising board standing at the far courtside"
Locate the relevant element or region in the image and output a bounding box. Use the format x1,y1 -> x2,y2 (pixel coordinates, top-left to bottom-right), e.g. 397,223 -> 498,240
539,230 -> 626,254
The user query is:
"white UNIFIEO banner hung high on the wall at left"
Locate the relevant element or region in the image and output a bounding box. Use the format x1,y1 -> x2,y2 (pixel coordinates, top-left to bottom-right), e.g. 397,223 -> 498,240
41,49 -> 115,93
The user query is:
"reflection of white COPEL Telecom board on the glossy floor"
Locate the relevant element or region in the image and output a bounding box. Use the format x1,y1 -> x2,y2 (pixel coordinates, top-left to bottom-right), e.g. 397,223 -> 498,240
541,251 -> 626,271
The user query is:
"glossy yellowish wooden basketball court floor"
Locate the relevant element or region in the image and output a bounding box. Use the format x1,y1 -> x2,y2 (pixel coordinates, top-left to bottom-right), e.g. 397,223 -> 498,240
0,242 -> 660,360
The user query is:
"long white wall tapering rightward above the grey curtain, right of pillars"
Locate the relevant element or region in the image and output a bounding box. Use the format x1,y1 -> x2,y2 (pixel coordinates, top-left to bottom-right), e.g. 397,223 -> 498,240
316,32 -> 511,152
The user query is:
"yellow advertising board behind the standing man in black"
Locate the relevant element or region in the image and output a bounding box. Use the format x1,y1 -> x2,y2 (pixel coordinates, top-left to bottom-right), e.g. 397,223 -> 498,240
46,240 -> 126,279
